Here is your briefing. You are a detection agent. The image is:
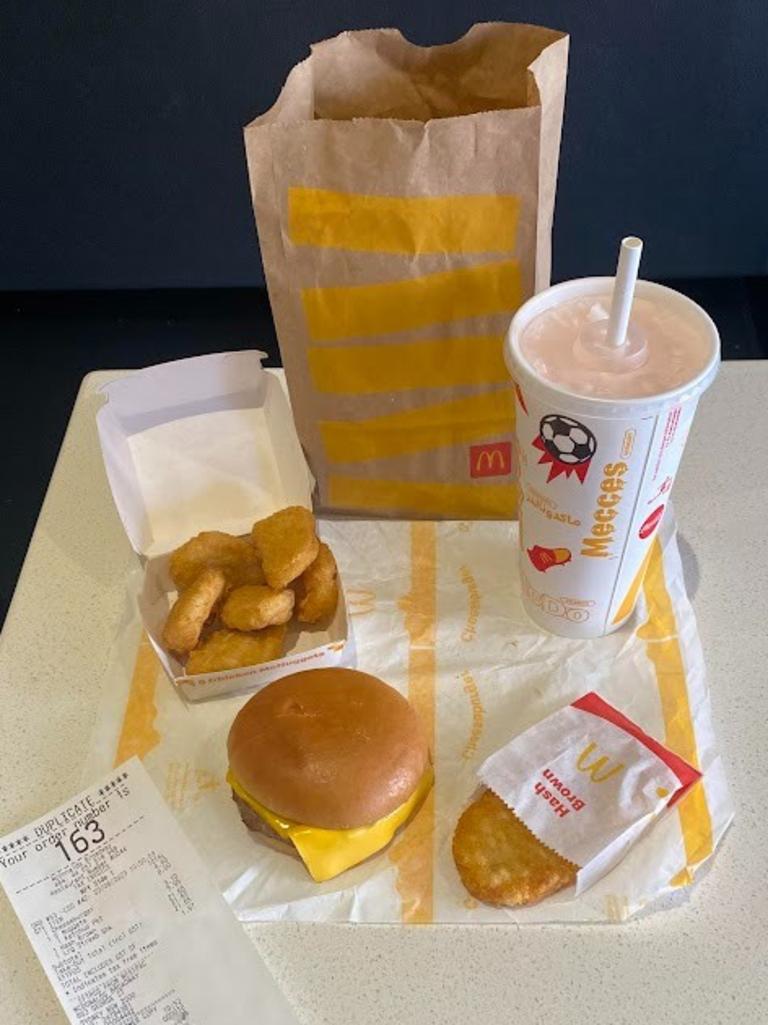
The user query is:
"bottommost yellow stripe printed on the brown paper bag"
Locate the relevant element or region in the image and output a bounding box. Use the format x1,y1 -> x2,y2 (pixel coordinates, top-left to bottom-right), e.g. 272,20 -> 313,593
328,474 -> 518,520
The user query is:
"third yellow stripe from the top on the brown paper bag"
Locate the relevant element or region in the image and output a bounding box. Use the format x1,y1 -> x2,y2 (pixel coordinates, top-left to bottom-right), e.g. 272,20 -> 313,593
308,334 -> 510,395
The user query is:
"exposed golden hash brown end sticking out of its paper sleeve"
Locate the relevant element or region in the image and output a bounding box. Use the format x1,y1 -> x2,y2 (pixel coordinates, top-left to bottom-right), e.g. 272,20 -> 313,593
453,790 -> 578,907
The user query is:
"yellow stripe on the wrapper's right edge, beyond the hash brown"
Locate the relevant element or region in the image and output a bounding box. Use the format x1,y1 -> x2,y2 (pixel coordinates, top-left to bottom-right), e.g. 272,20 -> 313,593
637,538 -> 714,886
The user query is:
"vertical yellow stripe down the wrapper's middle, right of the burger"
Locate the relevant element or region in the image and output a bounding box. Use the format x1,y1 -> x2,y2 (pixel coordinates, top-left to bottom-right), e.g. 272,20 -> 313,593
390,523 -> 437,924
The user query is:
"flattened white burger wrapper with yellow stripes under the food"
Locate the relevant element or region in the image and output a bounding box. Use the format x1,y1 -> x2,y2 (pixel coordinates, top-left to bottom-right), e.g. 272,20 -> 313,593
83,517 -> 733,925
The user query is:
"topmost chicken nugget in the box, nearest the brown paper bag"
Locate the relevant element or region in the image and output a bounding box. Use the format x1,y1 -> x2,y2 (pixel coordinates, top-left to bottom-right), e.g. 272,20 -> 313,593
251,505 -> 320,590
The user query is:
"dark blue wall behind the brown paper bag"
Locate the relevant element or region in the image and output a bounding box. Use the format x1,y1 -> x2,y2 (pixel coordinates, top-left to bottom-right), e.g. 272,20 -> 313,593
5,0 -> 768,289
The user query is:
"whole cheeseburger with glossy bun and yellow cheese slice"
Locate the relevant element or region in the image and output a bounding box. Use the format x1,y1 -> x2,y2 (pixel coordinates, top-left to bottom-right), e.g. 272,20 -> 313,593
227,669 -> 433,883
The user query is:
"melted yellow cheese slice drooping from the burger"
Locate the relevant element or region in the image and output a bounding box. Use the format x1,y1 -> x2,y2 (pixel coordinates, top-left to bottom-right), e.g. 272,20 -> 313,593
227,766 -> 435,883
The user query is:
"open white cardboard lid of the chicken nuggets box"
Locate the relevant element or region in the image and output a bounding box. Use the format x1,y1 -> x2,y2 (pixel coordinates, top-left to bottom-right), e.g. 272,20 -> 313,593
96,351 -> 314,558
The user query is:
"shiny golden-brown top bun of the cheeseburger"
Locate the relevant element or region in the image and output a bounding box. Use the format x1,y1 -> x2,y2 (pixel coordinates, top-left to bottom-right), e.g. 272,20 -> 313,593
228,668 -> 430,829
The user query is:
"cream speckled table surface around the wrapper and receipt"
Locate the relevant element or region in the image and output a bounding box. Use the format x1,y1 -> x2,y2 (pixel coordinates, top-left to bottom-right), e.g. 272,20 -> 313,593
0,362 -> 768,1025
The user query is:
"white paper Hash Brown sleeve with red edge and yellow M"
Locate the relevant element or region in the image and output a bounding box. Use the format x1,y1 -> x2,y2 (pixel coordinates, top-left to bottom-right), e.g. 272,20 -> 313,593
478,692 -> 701,894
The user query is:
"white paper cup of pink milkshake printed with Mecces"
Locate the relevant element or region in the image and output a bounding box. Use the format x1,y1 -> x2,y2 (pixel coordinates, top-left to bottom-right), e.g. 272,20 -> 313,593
504,255 -> 720,638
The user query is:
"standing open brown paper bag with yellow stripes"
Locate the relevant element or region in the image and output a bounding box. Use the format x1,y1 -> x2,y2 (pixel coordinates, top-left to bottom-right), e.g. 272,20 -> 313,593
245,24 -> 568,519
